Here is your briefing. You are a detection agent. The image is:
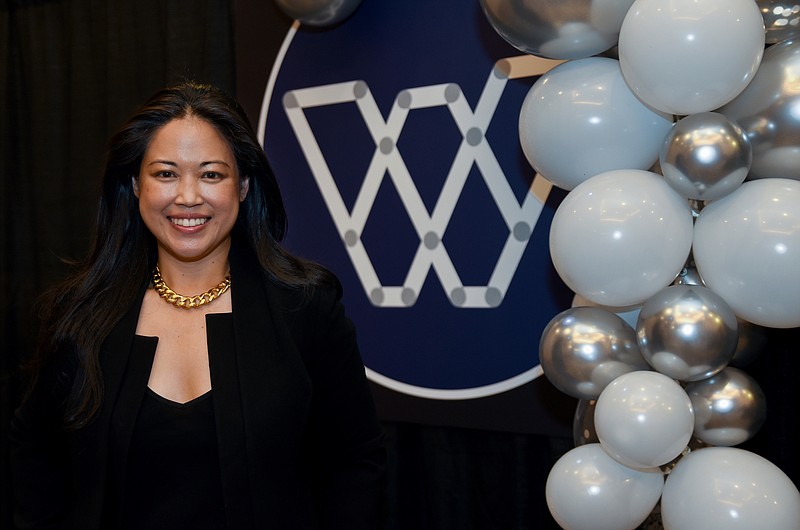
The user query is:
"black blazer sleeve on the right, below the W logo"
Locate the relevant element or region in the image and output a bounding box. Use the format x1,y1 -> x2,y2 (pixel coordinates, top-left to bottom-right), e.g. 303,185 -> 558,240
298,289 -> 386,530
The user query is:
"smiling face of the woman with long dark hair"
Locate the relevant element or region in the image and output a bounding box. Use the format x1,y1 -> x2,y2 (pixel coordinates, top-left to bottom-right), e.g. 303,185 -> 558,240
133,116 -> 248,261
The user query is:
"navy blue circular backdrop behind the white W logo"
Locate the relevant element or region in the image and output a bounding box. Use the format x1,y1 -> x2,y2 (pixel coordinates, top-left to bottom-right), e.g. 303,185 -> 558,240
262,0 -> 572,397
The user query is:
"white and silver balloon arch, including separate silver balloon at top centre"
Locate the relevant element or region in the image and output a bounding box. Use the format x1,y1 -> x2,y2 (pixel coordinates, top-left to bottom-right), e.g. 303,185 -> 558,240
276,0 -> 800,530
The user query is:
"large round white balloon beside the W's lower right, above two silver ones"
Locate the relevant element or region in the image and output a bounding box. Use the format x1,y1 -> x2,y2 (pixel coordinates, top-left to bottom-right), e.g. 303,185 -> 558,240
550,169 -> 693,306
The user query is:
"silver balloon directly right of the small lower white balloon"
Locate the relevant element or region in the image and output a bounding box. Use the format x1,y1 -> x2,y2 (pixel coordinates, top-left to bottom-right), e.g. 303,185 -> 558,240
686,366 -> 767,447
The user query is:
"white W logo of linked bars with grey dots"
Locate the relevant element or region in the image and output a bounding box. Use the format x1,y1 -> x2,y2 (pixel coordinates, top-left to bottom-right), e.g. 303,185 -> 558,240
283,56 -> 558,308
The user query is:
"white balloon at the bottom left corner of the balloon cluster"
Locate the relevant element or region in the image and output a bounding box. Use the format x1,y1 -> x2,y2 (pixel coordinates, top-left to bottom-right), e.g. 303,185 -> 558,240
545,443 -> 664,530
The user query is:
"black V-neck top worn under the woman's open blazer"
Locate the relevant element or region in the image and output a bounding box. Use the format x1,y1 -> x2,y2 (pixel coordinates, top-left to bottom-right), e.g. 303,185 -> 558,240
108,337 -> 226,530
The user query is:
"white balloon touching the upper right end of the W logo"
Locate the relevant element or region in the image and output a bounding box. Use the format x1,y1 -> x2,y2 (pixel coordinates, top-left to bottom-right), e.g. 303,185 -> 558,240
519,57 -> 672,190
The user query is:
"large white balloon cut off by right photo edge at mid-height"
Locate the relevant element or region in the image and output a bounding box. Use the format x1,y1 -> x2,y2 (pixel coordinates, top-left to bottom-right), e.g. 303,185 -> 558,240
693,178 -> 800,328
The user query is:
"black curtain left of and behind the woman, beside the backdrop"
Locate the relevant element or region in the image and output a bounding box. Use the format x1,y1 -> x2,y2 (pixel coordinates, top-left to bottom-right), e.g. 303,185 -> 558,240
0,0 -> 236,528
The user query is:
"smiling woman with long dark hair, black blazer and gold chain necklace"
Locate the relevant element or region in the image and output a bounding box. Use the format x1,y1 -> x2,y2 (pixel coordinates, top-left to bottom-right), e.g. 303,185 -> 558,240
11,83 -> 385,530
